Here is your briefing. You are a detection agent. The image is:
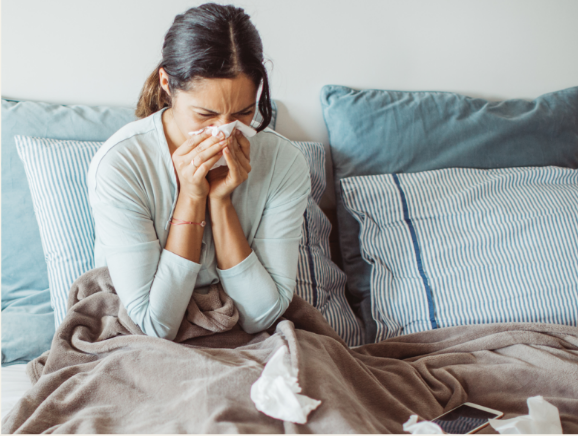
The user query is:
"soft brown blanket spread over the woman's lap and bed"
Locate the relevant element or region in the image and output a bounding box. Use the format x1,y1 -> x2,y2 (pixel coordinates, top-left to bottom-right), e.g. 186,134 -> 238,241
2,268 -> 578,433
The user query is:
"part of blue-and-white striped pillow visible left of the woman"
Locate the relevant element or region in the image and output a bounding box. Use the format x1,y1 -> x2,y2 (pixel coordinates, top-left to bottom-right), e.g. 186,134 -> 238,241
14,136 -> 103,327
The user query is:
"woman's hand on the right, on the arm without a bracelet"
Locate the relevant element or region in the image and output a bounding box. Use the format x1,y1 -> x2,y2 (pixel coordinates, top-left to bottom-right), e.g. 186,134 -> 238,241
207,129 -> 251,201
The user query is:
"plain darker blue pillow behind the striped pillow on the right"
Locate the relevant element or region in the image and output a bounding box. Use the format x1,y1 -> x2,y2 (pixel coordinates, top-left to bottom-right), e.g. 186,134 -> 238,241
321,85 -> 578,342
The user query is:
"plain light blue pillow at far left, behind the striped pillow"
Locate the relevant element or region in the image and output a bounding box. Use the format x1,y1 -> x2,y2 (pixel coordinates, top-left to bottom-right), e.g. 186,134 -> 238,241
2,99 -> 134,366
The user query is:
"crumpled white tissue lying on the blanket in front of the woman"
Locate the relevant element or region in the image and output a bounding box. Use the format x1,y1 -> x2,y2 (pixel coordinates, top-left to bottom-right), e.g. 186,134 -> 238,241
251,345 -> 321,424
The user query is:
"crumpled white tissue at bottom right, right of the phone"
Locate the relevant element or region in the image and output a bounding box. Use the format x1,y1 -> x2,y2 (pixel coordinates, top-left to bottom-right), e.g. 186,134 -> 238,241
489,395 -> 562,434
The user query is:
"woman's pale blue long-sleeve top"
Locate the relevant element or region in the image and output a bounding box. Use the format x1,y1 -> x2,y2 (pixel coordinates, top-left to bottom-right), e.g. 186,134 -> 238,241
88,110 -> 311,340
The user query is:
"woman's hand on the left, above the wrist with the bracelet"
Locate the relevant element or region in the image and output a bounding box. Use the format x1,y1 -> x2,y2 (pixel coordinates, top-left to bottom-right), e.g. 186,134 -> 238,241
172,131 -> 227,201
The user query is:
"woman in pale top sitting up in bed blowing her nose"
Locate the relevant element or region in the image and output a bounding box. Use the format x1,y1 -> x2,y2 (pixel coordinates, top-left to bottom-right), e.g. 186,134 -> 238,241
88,4 -> 311,340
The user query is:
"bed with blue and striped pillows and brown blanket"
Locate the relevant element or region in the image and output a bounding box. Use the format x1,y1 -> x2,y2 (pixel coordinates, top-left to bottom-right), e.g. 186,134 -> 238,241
2,85 -> 578,433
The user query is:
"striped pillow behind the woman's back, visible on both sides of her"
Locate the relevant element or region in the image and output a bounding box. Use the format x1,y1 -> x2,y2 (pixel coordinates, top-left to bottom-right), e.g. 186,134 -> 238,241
16,136 -> 362,346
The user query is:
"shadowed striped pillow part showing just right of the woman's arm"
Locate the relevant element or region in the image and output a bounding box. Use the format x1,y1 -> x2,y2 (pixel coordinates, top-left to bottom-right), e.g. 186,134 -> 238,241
293,141 -> 364,347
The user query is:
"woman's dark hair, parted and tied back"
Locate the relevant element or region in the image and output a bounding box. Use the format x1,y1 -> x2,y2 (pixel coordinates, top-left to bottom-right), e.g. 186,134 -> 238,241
136,3 -> 273,131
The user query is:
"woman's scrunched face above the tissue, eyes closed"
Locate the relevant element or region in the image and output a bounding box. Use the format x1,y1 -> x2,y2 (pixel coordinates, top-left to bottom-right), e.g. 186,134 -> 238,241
160,68 -> 257,138
